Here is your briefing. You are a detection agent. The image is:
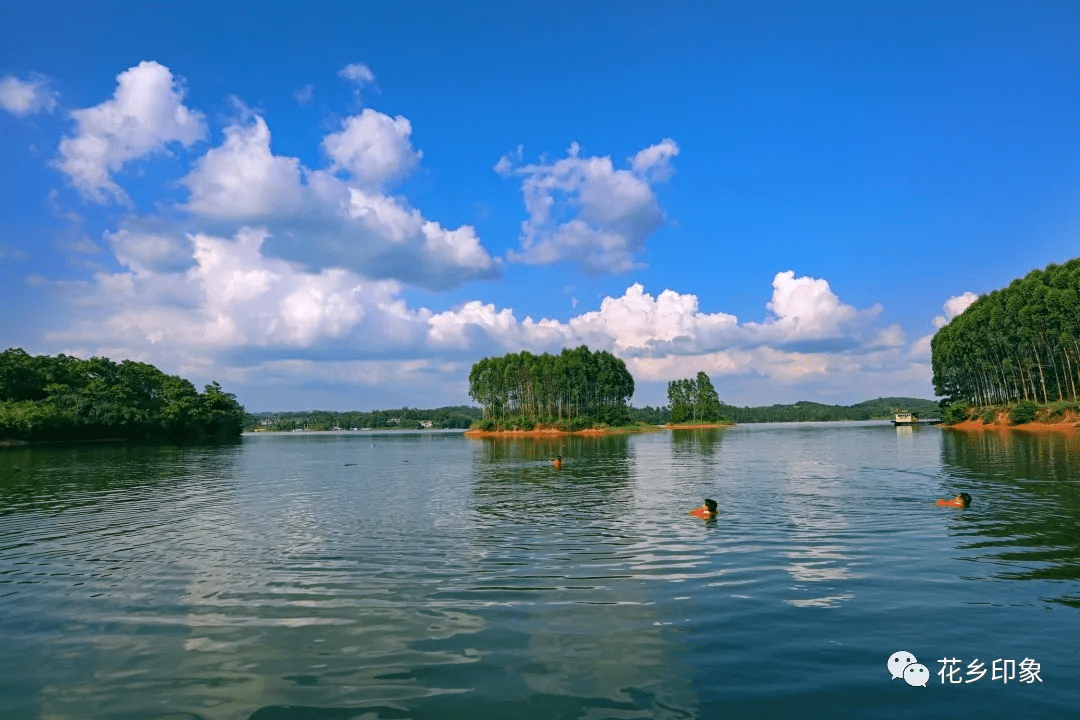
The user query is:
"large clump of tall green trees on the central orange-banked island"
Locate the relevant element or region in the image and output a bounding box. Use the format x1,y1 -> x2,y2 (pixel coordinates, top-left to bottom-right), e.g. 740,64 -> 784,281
469,345 -> 634,429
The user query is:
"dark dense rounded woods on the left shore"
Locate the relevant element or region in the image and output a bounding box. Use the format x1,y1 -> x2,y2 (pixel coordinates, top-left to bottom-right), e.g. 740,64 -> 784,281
0,348 -> 244,440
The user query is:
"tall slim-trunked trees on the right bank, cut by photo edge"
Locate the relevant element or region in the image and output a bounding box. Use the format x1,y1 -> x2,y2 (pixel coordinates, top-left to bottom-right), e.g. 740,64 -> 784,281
931,258 -> 1080,406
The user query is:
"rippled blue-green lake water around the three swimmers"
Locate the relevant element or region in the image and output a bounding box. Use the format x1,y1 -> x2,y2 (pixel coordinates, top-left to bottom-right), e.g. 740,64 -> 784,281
0,423 -> 1080,720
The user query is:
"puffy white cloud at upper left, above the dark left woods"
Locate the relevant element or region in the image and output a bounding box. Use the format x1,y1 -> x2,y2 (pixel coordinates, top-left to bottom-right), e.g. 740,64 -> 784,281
56,62 -> 206,202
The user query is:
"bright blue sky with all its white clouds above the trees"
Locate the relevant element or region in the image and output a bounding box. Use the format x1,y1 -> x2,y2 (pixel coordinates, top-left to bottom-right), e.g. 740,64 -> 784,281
0,2 -> 1080,411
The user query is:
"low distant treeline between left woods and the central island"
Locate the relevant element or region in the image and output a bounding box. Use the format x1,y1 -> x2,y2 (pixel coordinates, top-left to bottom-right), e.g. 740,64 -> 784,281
244,405 -> 482,432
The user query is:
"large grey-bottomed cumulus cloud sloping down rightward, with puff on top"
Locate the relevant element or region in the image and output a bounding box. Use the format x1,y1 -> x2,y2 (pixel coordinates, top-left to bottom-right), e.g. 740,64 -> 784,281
183,110 -> 501,289
